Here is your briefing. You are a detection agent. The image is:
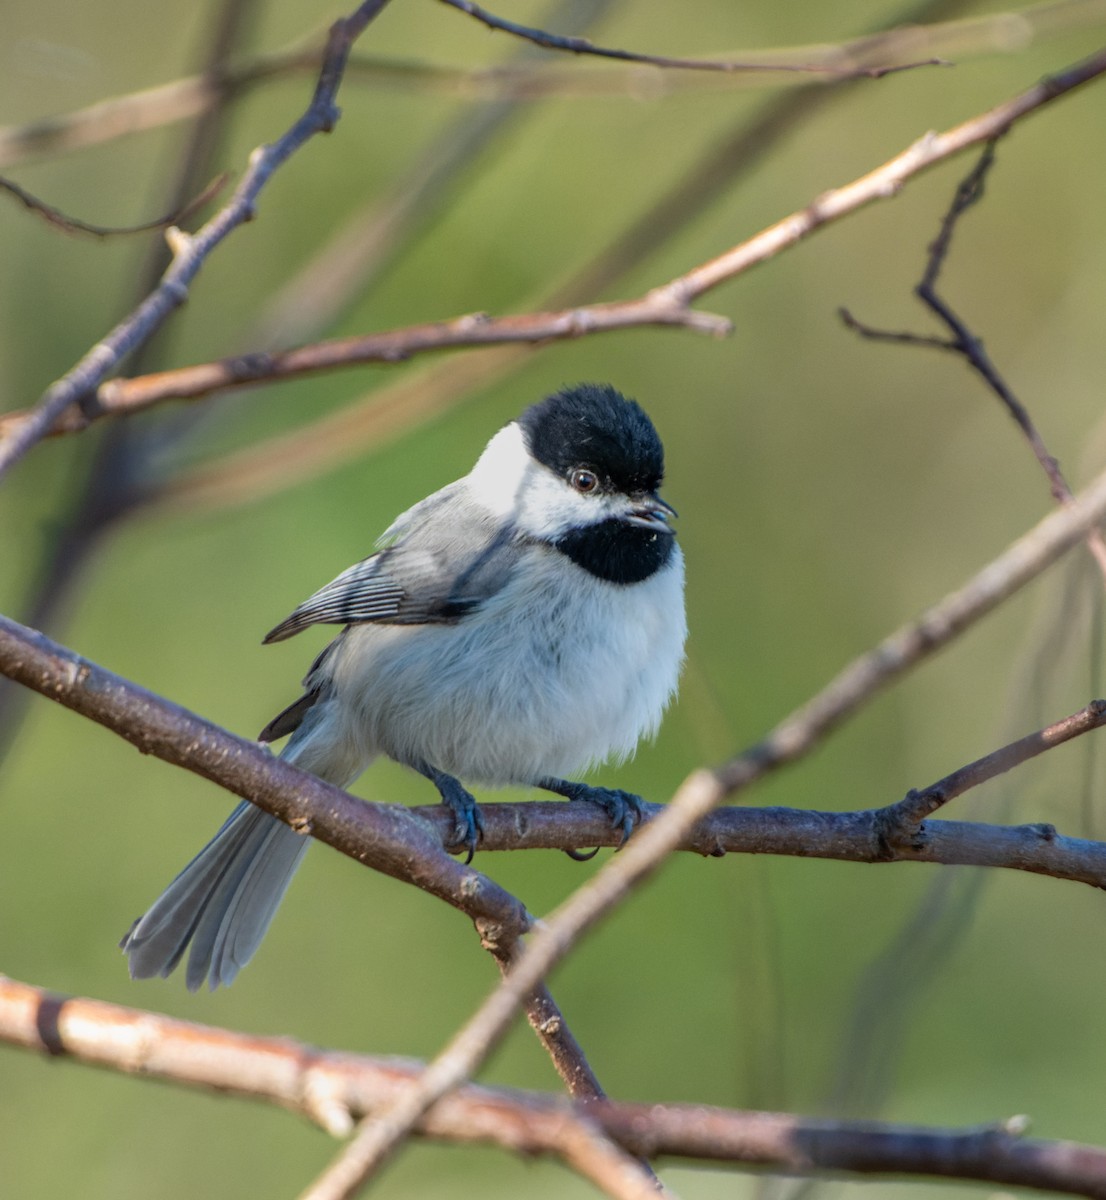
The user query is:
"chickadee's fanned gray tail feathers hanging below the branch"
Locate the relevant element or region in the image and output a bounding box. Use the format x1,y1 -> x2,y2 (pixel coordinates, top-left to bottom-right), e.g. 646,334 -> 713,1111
120,803 -> 311,991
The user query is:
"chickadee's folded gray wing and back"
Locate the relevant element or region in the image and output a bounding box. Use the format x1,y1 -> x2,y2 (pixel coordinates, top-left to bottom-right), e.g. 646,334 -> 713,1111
265,484 -> 524,643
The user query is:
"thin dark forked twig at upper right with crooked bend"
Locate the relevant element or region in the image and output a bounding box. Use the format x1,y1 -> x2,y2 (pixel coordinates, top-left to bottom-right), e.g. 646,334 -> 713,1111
840,139 -> 1106,578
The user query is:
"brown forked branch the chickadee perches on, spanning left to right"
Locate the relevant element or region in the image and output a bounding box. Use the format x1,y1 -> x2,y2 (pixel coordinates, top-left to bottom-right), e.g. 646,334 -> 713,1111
0,617 -> 1106,888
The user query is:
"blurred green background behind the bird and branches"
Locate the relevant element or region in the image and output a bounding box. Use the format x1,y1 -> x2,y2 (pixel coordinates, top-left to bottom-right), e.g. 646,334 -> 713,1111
0,0 -> 1106,1200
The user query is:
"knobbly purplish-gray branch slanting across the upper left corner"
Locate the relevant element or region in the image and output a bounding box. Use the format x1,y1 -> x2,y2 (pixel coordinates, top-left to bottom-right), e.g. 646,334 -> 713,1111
0,0 -> 387,487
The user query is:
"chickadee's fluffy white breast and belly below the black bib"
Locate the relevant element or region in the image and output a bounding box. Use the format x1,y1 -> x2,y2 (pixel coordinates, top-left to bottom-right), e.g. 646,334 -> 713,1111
314,542 -> 686,786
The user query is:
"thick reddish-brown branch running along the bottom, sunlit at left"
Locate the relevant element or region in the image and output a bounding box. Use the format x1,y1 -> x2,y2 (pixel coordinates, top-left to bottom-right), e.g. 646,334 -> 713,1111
0,977 -> 1106,1200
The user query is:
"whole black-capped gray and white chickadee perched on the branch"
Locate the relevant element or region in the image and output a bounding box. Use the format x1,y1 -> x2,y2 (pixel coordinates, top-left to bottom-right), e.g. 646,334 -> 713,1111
122,384 -> 687,991
